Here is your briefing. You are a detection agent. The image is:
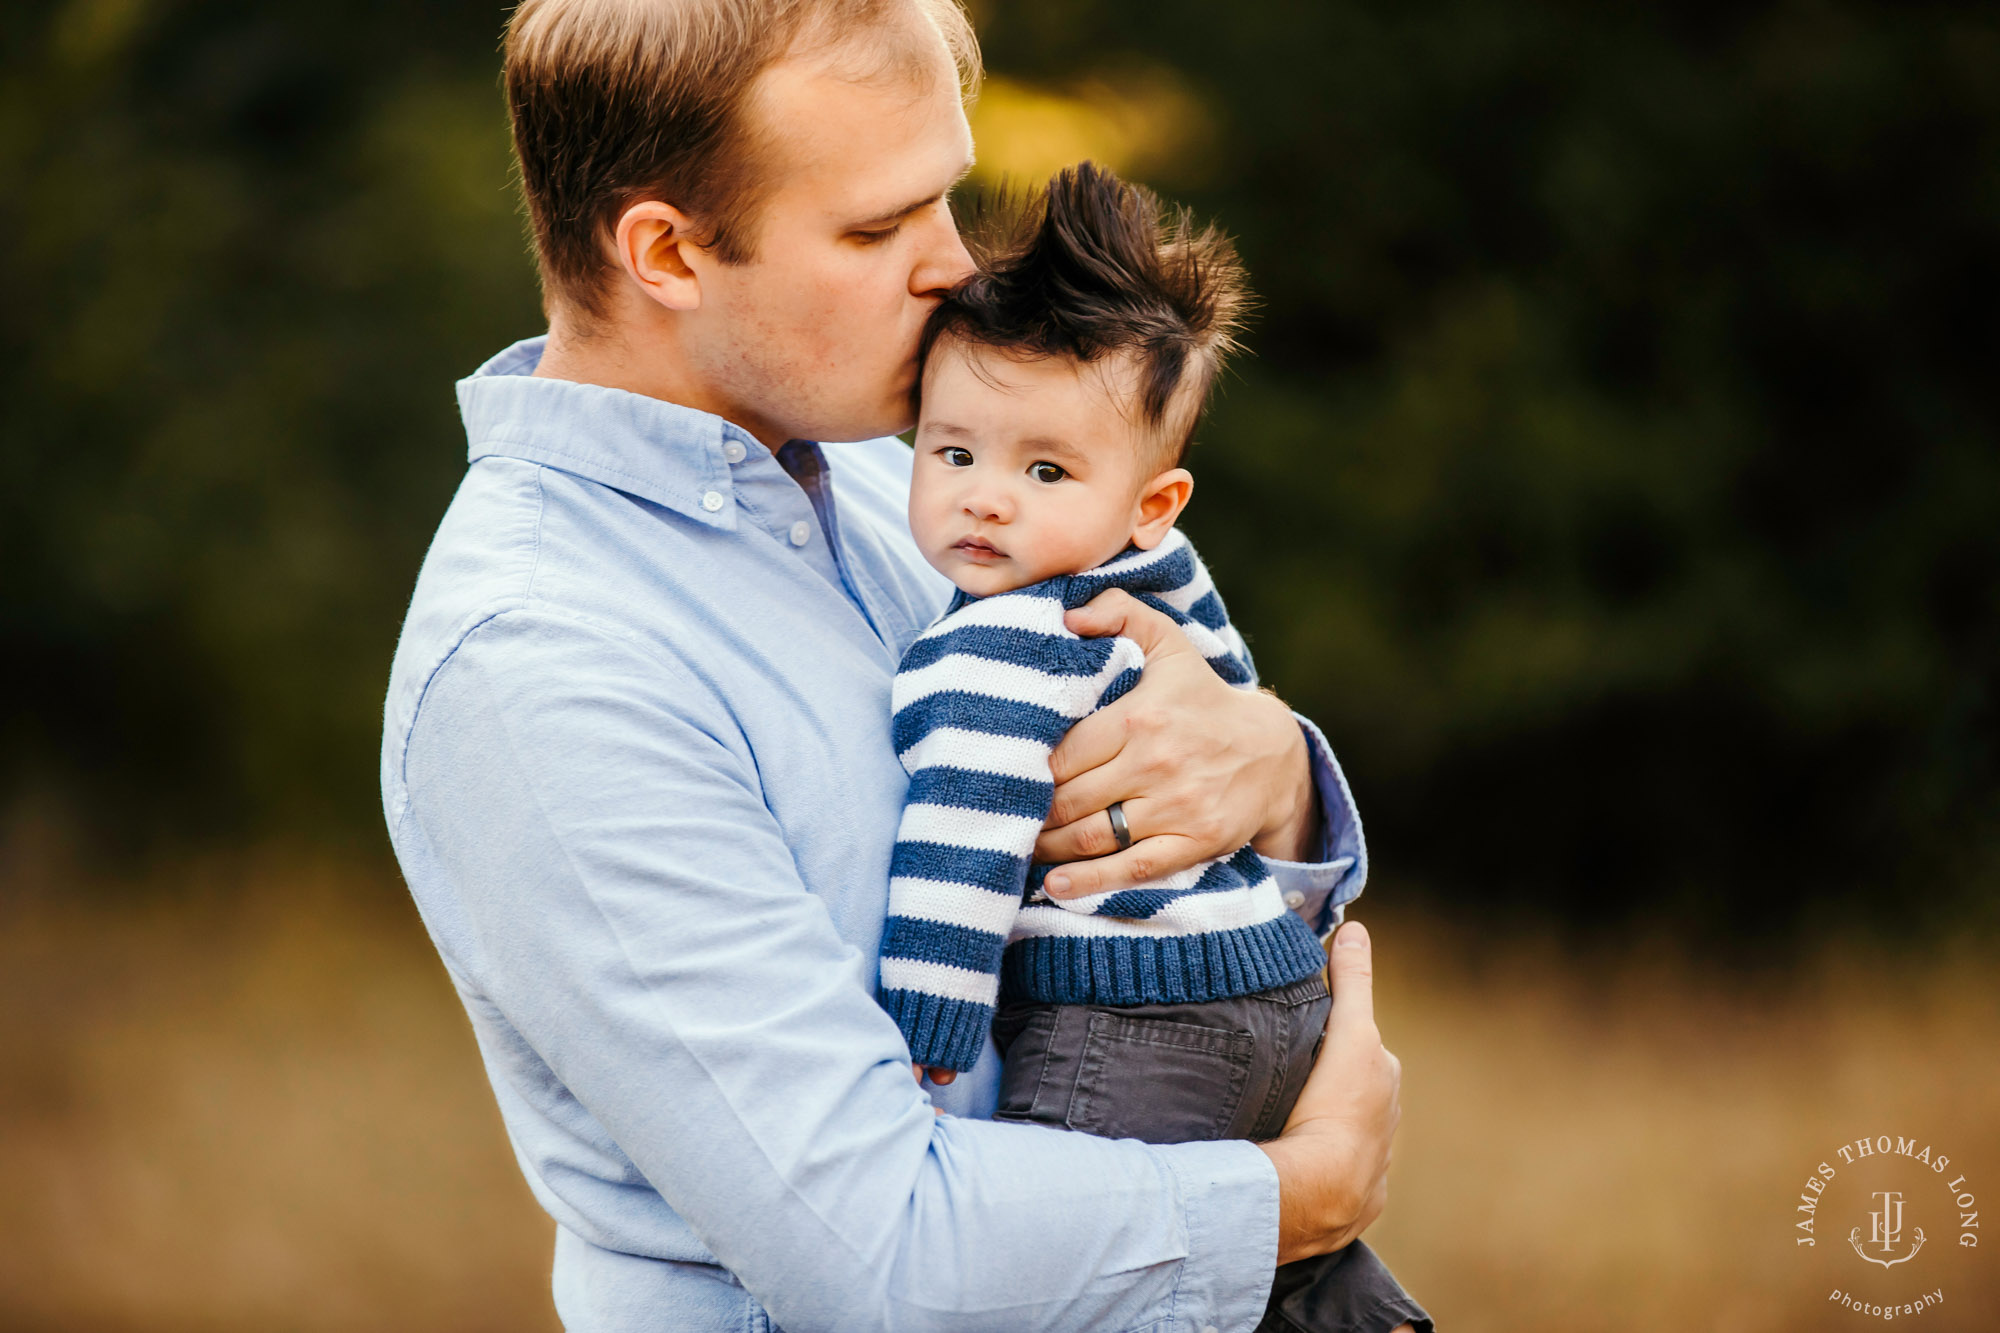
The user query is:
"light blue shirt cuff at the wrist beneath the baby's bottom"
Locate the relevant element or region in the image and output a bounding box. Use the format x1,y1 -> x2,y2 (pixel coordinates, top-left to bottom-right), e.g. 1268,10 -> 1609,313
1154,1139 -> 1278,1333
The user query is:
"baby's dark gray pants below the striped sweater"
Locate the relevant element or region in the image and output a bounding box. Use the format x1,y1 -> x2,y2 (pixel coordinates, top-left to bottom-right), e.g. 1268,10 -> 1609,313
994,964 -> 1432,1333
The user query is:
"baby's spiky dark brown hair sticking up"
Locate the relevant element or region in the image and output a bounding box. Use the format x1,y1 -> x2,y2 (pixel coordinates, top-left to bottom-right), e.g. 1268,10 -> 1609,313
922,162 -> 1250,466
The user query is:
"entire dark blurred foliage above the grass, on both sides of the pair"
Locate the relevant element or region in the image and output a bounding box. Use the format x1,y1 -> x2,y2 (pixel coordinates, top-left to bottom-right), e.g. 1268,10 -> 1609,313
0,0 -> 2000,945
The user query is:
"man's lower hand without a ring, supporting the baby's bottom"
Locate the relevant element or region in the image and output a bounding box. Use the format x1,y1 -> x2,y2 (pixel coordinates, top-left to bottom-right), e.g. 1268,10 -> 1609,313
1260,921 -> 1402,1263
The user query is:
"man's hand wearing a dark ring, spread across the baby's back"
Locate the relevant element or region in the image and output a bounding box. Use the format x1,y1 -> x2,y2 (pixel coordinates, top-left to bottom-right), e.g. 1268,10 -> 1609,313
1034,588 -> 1320,899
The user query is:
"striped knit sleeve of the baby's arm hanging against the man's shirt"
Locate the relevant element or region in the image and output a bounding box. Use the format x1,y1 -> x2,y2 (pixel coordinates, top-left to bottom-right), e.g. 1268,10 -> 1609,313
880,590 -> 1110,1071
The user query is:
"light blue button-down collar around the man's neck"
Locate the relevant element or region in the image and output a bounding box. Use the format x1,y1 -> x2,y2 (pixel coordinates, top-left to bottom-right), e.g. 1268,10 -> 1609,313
458,334 -> 770,530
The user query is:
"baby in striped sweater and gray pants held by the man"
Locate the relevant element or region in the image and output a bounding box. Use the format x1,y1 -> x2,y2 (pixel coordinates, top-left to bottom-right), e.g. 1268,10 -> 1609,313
882,164 -> 1430,1333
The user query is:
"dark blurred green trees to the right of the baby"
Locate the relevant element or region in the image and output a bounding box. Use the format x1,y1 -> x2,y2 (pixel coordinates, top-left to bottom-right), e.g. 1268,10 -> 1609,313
964,0 -> 2000,939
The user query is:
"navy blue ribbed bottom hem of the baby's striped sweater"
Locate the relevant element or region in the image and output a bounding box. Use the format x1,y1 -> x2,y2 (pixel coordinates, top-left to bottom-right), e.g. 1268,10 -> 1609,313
1000,913 -> 1326,1005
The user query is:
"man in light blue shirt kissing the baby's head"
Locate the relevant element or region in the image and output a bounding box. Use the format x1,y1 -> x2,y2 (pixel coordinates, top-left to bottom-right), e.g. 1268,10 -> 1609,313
382,0 -> 1398,1333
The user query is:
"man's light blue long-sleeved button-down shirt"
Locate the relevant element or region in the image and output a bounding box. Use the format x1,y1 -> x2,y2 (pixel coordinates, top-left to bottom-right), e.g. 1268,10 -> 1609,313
382,340 -> 1366,1333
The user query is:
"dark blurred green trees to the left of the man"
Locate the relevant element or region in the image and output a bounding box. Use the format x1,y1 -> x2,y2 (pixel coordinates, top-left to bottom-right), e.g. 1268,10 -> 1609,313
0,0 -> 540,847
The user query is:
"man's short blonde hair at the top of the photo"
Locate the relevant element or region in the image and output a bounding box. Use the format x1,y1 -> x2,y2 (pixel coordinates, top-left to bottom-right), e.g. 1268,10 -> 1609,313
506,0 -> 980,314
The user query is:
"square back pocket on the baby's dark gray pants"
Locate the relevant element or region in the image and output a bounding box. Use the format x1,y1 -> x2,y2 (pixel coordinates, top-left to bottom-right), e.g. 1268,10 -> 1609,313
1066,1009 -> 1256,1143
